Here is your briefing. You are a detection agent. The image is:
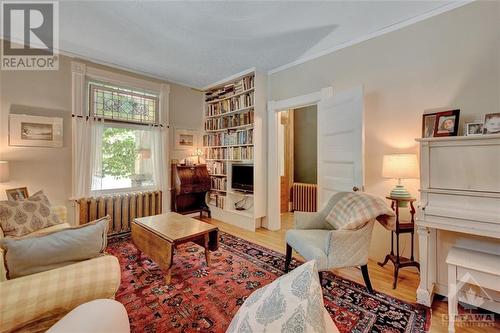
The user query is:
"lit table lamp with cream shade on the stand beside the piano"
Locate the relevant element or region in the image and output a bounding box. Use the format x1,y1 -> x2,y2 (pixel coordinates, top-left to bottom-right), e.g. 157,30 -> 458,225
382,154 -> 418,207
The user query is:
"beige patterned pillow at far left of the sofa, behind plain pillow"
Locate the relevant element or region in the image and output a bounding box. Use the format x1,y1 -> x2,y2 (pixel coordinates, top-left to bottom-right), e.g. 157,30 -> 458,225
0,191 -> 62,237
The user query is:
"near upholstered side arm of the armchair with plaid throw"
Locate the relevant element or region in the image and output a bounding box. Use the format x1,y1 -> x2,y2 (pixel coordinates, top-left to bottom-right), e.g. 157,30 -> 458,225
327,221 -> 375,268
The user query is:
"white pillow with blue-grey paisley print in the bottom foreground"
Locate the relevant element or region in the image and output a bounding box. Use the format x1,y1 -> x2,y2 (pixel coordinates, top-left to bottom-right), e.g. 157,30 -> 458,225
226,260 -> 325,333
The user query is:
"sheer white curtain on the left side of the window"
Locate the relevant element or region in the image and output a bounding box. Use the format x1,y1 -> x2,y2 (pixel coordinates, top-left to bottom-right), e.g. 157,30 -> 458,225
73,116 -> 104,199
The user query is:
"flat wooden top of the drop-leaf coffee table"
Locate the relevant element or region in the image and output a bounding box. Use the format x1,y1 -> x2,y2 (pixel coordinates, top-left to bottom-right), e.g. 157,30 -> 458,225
133,212 -> 218,243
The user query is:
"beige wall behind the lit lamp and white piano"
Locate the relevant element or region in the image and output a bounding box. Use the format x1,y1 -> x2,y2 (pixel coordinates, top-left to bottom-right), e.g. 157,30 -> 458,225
269,1 -> 500,260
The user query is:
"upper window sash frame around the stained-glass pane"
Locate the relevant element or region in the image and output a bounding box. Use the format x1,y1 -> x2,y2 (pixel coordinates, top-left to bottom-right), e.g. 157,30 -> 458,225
88,82 -> 160,126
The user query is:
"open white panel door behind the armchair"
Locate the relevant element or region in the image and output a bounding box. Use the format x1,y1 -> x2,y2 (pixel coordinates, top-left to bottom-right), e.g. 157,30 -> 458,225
318,87 -> 364,210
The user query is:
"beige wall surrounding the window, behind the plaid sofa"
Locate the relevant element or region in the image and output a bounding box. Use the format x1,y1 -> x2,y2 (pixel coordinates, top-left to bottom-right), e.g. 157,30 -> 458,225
0,56 -> 203,222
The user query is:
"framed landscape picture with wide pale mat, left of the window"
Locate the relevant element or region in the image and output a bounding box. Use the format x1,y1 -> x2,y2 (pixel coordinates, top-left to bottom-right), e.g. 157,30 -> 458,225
9,114 -> 63,147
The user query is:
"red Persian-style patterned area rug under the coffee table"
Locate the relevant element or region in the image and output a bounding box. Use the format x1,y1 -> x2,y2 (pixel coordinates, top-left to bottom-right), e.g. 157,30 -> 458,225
108,232 -> 430,333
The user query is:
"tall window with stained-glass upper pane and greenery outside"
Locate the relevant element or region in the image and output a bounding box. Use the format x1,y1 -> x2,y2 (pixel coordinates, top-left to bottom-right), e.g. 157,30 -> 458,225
87,81 -> 162,193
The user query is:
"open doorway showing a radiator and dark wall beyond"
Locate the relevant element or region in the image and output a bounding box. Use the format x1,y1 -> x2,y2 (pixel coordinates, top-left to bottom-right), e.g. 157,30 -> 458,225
278,104 -> 318,215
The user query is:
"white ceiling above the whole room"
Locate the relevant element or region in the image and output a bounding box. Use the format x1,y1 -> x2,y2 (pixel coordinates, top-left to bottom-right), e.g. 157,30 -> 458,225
59,1 -> 458,88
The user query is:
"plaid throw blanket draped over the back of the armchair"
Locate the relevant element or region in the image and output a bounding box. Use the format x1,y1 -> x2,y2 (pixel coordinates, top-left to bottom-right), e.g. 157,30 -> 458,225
326,192 -> 396,230
